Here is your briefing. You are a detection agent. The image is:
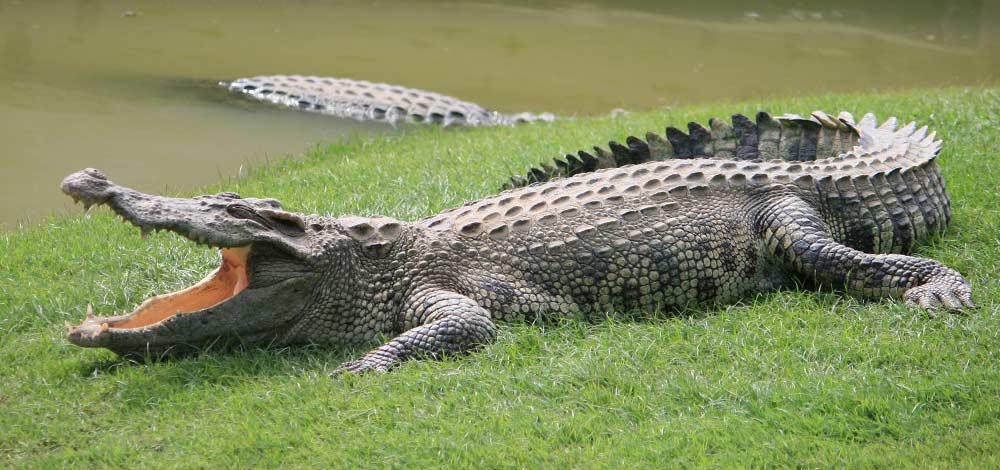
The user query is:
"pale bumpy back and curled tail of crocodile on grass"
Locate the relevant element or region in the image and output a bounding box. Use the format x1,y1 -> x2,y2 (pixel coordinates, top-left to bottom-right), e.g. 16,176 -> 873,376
442,113 -> 950,253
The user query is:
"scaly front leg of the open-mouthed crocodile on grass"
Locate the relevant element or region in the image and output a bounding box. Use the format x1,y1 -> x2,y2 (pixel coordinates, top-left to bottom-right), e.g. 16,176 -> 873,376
334,291 -> 496,375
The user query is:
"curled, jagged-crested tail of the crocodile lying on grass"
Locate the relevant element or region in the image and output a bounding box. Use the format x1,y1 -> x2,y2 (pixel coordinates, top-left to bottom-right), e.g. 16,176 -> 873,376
506,112 -> 951,253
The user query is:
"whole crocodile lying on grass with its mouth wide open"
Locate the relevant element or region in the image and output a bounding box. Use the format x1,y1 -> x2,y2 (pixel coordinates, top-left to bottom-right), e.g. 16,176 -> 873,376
62,112 -> 975,373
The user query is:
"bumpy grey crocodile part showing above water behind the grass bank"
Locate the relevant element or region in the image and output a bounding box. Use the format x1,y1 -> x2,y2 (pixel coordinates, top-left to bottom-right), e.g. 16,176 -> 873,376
222,75 -> 555,126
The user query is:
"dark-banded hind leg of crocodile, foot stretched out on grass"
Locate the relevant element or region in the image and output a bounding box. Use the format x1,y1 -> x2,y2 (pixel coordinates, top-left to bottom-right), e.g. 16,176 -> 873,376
755,195 -> 975,315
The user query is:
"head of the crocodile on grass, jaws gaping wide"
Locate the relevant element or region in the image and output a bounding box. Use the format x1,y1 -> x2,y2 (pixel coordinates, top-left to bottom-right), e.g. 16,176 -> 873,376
62,169 -> 336,357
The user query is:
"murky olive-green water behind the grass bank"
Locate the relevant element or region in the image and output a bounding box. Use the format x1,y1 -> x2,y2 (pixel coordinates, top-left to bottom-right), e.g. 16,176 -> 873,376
0,0 -> 1000,225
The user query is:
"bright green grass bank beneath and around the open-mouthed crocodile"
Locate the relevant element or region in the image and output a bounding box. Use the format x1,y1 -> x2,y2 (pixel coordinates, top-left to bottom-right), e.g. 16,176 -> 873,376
0,89 -> 1000,468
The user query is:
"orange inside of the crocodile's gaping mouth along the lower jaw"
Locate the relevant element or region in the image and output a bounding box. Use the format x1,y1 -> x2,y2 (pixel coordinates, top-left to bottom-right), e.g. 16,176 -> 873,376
69,246 -> 250,344
